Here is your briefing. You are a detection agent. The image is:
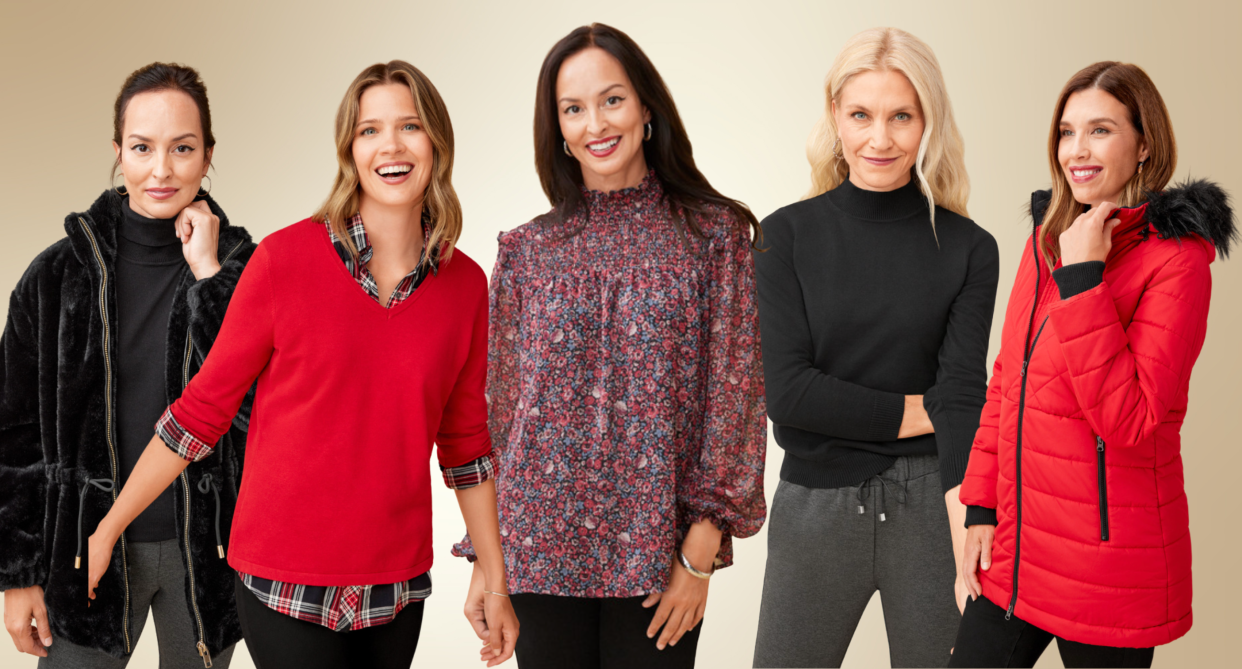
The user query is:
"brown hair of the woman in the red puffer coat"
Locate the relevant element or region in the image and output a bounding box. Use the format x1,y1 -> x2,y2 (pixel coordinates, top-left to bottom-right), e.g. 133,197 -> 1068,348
1037,61 -> 1177,267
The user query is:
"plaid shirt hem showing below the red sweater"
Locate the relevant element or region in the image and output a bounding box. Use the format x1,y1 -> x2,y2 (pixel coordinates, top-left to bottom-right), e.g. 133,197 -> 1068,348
237,572 -> 431,632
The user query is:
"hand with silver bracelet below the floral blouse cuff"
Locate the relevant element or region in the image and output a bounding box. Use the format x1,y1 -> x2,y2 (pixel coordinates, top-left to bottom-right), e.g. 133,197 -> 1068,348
642,520 -> 722,650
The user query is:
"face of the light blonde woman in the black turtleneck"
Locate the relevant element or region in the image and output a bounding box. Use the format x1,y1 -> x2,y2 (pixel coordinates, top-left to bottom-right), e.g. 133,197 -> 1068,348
832,71 -> 924,191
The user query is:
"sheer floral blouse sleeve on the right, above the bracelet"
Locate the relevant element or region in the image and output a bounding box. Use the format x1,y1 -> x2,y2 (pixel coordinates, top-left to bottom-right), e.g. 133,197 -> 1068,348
677,222 -> 768,553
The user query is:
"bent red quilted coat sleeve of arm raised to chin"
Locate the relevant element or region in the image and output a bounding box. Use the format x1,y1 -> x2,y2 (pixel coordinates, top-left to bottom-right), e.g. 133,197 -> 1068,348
1048,248 -> 1212,448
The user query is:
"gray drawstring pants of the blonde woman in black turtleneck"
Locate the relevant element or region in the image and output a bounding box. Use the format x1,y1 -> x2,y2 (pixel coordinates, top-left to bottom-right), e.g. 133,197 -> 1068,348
755,456 -> 961,667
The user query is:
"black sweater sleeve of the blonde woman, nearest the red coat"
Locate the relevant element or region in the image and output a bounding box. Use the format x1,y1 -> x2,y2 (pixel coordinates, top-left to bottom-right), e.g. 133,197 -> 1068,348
923,228 -> 1000,493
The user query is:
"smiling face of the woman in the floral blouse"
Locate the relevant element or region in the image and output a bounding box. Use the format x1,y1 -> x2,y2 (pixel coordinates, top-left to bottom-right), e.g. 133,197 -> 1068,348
556,47 -> 651,191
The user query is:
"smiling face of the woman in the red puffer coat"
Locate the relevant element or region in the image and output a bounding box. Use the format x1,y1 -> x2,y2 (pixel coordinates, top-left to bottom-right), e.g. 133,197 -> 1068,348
1057,88 -> 1148,206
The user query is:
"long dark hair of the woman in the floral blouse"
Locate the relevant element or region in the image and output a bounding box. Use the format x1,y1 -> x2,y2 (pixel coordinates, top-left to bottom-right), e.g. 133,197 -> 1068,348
535,24 -> 763,246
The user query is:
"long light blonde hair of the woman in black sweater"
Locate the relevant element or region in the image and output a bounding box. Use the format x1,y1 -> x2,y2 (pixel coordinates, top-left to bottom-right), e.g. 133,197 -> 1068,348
804,27 -> 970,232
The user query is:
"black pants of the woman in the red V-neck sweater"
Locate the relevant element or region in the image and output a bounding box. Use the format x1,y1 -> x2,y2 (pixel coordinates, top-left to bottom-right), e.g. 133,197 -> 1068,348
233,578 -> 427,669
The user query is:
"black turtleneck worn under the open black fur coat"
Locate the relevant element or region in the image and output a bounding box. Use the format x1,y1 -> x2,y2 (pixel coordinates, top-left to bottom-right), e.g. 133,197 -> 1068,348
116,199 -> 186,541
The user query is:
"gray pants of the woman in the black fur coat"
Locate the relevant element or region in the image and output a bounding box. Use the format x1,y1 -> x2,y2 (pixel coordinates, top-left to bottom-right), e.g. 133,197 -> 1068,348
39,539 -> 235,669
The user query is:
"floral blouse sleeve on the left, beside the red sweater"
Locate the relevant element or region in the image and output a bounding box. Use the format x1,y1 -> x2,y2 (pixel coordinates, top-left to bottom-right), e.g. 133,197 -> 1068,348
452,235 -> 522,562
